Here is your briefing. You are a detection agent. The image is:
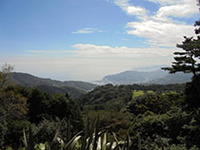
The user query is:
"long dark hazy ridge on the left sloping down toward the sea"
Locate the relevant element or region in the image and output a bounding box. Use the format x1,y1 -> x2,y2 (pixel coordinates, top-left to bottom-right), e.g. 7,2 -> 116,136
11,72 -> 97,98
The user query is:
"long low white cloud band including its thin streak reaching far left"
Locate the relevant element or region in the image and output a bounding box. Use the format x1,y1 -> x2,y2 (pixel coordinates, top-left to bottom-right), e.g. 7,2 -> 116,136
27,44 -> 174,57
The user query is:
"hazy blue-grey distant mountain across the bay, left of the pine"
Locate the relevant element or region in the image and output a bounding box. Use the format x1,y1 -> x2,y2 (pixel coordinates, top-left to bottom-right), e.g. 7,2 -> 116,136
102,69 -> 192,85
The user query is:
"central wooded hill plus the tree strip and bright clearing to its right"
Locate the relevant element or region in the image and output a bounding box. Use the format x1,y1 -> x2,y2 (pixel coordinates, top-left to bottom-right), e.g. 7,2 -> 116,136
81,84 -> 184,111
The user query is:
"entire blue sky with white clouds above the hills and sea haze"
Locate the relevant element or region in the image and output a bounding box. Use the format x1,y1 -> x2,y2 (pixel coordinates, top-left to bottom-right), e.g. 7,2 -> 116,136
0,0 -> 200,81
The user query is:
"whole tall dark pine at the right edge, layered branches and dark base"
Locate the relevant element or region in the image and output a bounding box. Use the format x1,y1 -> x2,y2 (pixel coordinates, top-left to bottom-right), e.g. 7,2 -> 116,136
163,21 -> 200,108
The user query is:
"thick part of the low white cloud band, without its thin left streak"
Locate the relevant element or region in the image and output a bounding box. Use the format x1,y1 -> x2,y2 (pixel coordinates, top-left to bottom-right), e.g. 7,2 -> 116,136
73,44 -> 174,59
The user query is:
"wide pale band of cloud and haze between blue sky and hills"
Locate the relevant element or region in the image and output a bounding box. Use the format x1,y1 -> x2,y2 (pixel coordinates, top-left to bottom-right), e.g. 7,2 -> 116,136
1,43 -> 174,81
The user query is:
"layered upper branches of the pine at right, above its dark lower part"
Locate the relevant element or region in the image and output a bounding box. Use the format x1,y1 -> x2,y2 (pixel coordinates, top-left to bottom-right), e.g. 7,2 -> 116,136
163,21 -> 200,78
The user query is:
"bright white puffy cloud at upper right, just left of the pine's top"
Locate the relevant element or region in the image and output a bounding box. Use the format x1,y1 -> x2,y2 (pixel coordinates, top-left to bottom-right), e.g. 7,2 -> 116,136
127,20 -> 194,47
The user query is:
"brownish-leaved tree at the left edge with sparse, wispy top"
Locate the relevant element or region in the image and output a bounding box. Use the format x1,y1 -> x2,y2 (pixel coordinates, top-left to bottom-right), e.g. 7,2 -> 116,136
0,64 -> 28,149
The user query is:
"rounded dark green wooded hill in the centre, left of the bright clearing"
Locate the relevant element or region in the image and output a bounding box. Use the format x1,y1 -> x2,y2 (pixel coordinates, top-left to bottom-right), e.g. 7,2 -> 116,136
81,84 -> 132,111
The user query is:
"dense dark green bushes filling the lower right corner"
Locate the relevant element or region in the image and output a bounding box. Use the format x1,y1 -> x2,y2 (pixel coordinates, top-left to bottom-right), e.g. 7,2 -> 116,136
128,92 -> 200,149
